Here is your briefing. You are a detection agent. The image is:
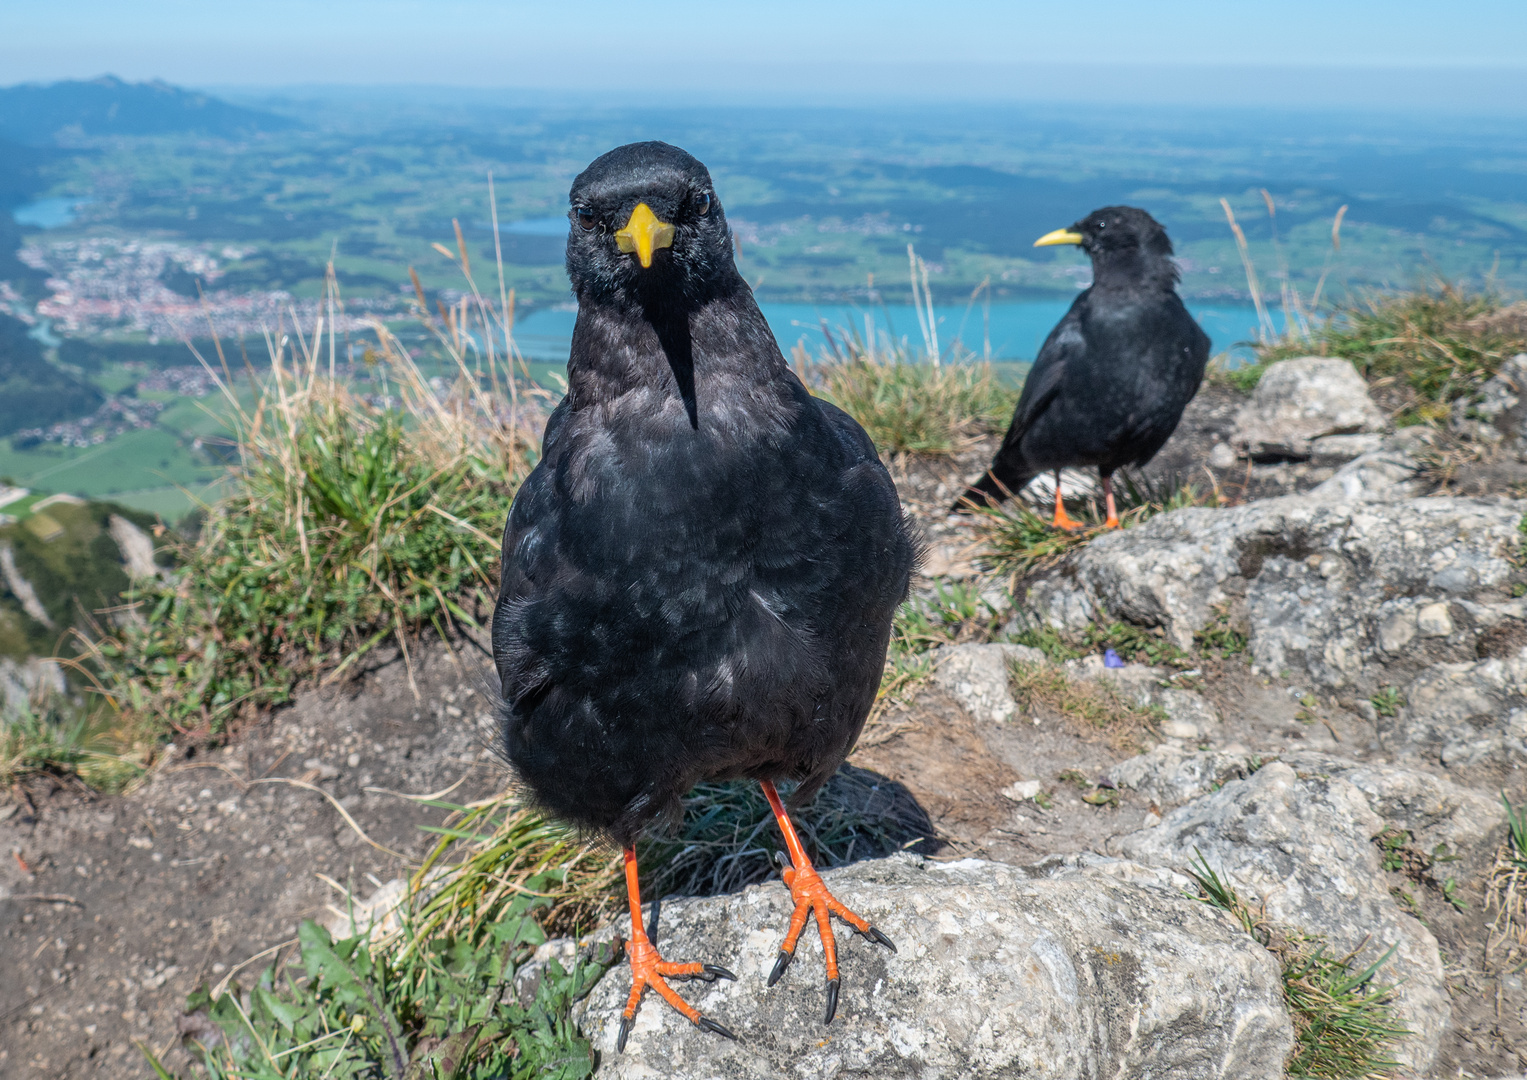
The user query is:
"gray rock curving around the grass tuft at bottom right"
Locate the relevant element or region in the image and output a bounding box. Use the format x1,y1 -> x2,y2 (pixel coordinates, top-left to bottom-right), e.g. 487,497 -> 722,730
1119,761 -> 1451,1075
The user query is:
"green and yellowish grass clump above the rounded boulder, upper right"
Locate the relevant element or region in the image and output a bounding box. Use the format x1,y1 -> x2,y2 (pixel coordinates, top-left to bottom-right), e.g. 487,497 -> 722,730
1246,281 -> 1527,425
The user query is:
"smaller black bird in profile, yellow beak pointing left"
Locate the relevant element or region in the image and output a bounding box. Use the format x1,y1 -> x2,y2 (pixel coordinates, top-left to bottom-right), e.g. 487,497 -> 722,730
954,206 -> 1209,529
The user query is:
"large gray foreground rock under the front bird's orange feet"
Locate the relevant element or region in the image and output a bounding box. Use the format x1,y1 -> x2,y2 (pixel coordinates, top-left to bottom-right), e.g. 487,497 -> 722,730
574,855 -> 1292,1080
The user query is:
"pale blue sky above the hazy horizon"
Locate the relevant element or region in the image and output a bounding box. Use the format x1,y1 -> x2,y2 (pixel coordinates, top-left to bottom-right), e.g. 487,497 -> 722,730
0,0 -> 1527,107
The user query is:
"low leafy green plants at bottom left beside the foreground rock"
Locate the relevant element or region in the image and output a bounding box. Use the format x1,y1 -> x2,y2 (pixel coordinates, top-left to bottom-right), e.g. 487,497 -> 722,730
145,883 -> 617,1080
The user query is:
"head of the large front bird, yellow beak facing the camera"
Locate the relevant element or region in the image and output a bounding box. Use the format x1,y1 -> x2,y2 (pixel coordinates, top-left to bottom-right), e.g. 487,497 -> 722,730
568,142 -> 738,302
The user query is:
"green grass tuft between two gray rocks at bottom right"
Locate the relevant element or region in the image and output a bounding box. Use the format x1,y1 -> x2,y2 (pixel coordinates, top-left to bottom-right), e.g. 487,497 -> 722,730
1188,852 -> 1409,1080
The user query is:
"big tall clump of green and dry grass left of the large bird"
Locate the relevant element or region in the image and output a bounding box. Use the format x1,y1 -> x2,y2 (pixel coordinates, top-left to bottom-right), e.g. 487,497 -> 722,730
86,338 -> 531,730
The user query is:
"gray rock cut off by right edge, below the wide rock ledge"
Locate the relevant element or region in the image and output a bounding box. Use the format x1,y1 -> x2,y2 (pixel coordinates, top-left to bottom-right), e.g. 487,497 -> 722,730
1379,654 -> 1527,765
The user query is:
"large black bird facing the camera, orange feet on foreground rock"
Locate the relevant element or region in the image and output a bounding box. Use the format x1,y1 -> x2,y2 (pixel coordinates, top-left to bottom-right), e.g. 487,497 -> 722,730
493,142 -> 915,1048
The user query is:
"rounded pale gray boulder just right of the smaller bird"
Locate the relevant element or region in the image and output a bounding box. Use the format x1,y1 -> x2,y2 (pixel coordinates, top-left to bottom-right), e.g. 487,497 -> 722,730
1231,356 -> 1385,460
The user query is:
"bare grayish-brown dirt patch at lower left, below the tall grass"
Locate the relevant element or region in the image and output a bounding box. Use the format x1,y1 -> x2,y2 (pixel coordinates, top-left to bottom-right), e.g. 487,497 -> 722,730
0,646 -> 505,1078
